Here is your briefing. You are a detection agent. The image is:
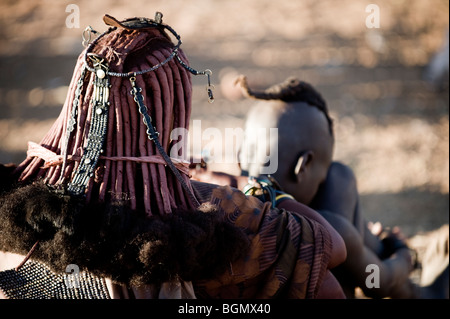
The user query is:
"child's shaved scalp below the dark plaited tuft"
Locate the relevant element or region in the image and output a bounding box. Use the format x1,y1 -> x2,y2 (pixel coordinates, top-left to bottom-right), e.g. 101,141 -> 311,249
240,100 -> 334,202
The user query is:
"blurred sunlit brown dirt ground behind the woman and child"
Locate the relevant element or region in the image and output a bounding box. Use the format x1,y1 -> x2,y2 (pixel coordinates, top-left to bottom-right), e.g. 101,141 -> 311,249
0,0 -> 449,298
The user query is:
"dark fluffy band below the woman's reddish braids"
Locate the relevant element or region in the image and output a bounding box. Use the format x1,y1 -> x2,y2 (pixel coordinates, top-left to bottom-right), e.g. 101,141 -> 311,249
0,182 -> 249,286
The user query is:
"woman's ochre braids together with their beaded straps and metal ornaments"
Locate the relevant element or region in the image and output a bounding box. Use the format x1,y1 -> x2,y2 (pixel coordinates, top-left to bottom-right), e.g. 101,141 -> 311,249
18,12 -> 213,215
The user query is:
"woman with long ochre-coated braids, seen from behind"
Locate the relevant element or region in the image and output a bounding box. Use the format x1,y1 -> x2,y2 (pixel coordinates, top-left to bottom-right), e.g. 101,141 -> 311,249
0,13 -> 346,299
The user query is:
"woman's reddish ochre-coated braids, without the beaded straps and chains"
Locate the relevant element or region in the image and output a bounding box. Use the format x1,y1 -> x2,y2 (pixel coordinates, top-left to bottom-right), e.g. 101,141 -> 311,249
16,16 -> 195,216
